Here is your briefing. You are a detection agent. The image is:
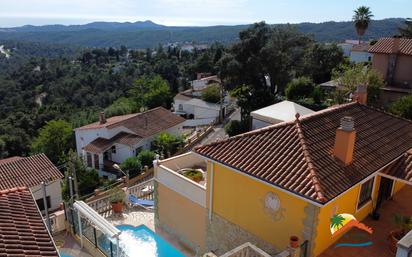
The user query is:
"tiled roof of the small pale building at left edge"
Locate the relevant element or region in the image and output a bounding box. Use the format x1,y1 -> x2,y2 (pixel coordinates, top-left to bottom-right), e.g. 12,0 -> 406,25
0,154 -> 63,190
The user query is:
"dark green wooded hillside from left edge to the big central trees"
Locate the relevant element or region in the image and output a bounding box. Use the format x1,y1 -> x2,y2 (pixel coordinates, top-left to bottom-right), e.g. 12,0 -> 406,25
0,23 -> 350,162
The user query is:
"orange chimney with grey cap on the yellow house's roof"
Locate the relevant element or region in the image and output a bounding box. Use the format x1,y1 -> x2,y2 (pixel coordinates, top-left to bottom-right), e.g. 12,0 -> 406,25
333,117 -> 356,166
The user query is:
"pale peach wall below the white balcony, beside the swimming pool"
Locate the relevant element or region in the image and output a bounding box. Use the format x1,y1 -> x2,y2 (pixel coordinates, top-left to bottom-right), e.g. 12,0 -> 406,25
157,183 -> 206,249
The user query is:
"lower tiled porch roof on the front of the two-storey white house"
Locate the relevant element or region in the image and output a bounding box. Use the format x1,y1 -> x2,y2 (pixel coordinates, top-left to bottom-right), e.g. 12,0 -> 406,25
83,132 -> 142,153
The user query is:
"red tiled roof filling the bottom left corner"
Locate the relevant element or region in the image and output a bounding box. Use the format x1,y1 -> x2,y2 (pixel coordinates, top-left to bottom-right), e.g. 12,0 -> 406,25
0,187 -> 59,257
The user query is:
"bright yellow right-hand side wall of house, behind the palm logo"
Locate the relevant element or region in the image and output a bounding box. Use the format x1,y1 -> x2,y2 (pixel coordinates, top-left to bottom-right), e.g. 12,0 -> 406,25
314,176 -> 380,256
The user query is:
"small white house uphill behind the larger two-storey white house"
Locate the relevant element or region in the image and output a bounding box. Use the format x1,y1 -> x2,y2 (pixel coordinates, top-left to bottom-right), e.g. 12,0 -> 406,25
173,76 -> 233,127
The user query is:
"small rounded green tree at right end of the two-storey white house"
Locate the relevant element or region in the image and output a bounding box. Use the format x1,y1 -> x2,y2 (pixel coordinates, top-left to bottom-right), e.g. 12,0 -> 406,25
152,132 -> 184,157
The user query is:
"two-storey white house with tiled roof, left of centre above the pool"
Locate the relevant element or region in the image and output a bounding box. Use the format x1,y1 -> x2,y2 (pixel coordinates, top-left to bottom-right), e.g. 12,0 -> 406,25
74,107 -> 185,178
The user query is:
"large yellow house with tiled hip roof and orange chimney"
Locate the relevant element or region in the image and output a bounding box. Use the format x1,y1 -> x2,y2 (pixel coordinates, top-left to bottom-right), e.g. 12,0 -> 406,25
155,103 -> 412,256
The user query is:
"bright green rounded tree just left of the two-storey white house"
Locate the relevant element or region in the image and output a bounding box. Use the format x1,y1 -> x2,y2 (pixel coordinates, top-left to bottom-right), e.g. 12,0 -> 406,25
31,120 -> 73,164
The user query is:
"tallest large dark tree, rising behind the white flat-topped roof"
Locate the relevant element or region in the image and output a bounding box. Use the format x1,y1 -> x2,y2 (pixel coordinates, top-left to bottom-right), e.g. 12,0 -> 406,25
219,22 -> 313,120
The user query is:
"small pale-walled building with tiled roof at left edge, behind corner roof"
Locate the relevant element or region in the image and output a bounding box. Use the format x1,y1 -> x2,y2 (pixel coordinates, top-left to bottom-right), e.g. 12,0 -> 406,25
0,154 -> 64,211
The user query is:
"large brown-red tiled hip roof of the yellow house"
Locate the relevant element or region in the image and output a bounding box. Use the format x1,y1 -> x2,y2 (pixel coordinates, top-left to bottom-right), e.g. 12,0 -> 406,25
194,103 -> 412,203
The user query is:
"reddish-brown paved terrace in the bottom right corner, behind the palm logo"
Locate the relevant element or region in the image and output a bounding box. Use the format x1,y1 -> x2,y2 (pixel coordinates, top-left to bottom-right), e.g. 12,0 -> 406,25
320,185 -> 412,257
